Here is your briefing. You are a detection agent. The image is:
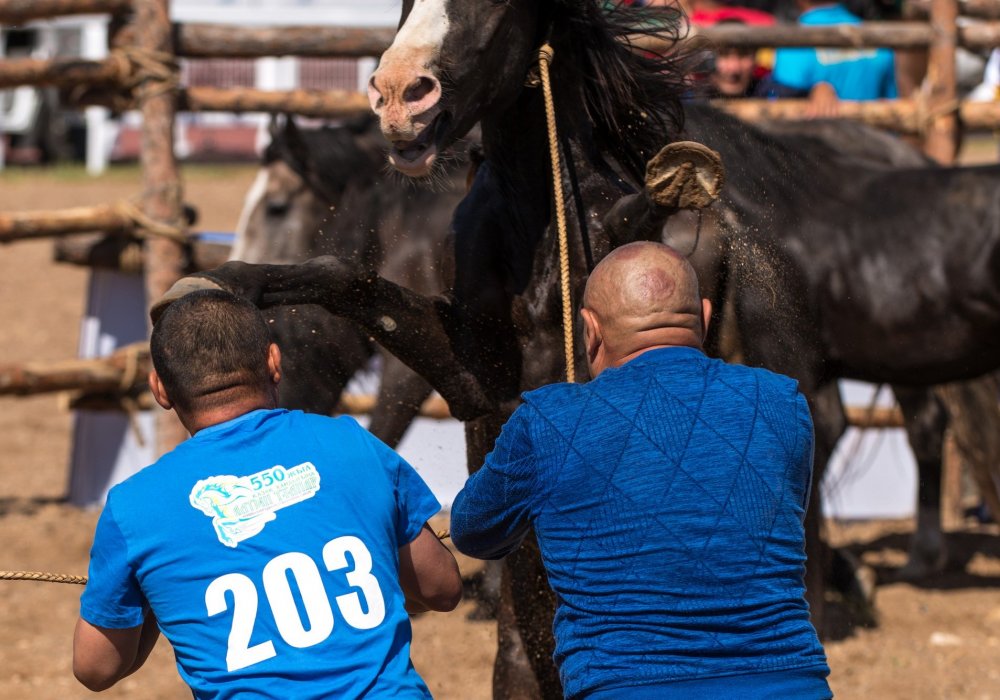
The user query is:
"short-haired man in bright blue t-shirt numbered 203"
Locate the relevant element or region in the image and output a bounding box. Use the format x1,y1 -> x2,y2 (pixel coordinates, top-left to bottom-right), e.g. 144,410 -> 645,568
73,290 -> 462,700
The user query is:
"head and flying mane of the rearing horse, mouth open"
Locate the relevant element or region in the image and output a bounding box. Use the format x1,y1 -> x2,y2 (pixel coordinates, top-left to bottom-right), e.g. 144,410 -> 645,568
368,0 -> 687,182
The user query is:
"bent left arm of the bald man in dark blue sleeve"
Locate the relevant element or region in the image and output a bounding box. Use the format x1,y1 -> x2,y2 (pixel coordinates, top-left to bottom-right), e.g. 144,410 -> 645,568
451,404 -> 535,559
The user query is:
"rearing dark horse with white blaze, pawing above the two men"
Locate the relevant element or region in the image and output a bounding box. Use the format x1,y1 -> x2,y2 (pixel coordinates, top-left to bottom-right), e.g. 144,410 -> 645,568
154,0 -> 712,697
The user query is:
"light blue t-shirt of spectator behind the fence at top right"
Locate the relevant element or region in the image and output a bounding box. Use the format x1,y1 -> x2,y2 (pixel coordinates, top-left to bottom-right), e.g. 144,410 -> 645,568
770,5 -> 897,100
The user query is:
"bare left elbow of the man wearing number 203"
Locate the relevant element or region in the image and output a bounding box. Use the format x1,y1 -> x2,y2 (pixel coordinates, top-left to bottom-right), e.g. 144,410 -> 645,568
73,613 -> 160,692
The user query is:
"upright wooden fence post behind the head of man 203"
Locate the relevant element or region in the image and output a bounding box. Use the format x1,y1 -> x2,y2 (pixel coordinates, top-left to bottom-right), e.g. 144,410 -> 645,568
133,0 -> 188,452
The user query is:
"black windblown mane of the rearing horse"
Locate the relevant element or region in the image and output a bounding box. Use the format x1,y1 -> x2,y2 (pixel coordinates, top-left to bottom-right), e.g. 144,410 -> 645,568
551,0 -> 693,182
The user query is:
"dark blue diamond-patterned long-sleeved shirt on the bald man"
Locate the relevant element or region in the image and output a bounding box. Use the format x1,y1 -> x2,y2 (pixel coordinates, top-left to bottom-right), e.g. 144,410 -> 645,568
451,347 -> 830,699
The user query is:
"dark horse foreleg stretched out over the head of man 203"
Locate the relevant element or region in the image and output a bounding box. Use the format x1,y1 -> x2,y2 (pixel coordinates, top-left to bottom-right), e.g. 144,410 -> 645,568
151,256 -> 495,420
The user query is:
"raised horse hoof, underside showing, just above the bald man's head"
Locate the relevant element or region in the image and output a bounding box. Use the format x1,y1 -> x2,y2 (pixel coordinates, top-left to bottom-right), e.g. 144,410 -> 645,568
646,141 -> 725,209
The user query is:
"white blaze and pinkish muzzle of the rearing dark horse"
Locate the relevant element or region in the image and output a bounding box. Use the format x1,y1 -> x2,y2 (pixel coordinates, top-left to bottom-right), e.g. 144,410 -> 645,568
368,0 -> 450,149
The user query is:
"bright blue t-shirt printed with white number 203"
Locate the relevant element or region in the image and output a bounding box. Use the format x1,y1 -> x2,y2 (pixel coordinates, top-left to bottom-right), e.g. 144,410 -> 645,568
80,409 -> 440,700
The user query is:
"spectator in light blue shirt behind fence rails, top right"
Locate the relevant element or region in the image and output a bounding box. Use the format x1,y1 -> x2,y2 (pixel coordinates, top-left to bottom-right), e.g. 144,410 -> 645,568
764,0 -> 898,116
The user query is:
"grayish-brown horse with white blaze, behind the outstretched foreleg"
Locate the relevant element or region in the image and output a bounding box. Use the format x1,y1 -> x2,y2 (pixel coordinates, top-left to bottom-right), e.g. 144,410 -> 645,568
230,116 -> 467,446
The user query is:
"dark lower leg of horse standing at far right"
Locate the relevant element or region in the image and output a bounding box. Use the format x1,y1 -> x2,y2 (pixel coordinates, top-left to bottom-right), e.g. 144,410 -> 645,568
892,386 -> 948,579
